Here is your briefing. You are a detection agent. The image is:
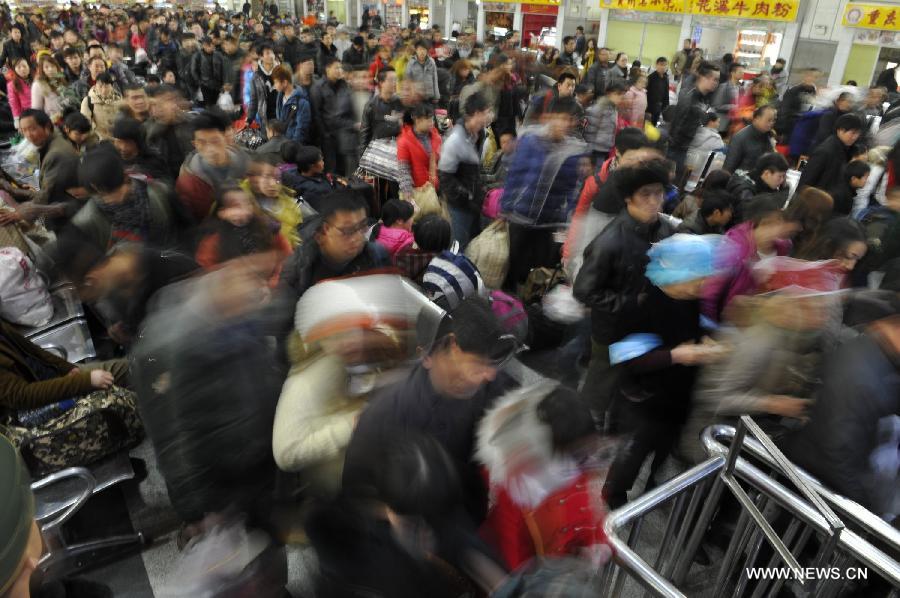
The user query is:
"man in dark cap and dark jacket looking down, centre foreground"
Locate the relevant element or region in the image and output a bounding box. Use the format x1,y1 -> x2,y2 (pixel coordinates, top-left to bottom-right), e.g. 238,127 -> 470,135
343,297 -> 520,522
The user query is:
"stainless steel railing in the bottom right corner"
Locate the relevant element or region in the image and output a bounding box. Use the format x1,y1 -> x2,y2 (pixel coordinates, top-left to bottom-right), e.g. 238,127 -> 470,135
601,417 -> 900,598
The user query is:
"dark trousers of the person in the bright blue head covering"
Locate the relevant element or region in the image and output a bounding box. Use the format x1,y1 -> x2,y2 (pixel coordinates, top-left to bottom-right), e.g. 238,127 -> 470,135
603,399 -> 681,509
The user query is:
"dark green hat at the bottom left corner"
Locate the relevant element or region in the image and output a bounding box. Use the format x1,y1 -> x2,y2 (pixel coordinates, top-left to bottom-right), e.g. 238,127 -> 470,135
0,436 -> 34,595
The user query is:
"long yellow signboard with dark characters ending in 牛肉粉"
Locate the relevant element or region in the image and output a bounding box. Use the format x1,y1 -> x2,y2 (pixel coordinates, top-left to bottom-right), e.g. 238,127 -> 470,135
600,0 -> 801,21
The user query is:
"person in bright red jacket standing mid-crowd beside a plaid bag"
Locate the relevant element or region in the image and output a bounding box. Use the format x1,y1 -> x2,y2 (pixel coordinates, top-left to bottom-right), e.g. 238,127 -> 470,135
397,103 -> 441,199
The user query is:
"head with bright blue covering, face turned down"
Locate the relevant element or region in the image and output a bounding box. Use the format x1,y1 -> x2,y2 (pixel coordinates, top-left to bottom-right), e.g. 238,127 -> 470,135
646,233 -> 722,300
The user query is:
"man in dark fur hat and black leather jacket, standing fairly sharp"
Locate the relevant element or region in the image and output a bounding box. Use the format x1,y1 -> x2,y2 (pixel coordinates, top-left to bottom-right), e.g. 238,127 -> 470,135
573,160 -> 675,418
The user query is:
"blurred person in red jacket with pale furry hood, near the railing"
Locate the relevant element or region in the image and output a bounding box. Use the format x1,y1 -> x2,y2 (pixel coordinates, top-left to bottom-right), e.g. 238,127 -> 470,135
475,381 -> 612,569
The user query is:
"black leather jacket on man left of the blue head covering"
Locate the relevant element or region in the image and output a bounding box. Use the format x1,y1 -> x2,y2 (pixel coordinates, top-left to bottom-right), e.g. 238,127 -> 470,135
573,210 -> 675,345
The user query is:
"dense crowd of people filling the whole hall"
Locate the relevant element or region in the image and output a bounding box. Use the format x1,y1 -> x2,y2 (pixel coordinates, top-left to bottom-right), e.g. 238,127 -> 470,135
0,2 -> 900,598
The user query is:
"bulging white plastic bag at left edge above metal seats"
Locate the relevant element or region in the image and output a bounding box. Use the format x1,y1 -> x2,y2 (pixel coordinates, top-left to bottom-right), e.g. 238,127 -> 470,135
0,247 -> 53,328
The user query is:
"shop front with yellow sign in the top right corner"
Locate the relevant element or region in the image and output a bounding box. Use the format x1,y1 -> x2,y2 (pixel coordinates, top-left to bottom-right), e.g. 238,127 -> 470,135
841,2 -> 900,87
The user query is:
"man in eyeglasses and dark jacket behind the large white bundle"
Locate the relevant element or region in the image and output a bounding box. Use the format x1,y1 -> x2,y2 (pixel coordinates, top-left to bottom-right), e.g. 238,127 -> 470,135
278,189 -> 391,330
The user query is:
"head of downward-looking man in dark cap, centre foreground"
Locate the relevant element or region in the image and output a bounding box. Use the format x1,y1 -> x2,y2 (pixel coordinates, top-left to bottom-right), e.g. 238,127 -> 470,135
422,296 -> 518,400
